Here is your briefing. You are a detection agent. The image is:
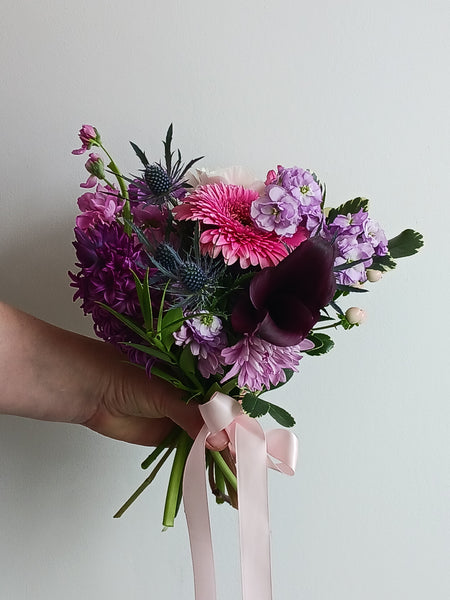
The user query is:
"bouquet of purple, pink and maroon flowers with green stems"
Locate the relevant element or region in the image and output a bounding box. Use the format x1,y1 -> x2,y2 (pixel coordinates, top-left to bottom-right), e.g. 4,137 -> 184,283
71,125 -> 423,598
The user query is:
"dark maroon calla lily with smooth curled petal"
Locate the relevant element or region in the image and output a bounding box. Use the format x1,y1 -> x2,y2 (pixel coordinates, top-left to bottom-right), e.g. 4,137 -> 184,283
231,236 -> 336,346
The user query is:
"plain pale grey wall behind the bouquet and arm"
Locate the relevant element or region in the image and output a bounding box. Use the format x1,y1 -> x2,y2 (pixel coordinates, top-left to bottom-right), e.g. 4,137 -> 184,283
0,0 -> 450,600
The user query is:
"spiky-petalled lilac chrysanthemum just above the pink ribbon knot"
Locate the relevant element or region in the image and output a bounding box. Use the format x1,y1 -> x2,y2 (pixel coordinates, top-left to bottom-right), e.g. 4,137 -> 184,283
221,334 -> 313,392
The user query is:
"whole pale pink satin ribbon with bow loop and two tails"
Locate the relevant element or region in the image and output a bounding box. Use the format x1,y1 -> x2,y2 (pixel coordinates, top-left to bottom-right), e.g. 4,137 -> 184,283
183,392 -> 298,600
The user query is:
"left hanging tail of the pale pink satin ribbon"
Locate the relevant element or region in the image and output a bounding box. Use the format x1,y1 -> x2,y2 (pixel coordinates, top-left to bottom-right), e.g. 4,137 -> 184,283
183,425 -> 216,600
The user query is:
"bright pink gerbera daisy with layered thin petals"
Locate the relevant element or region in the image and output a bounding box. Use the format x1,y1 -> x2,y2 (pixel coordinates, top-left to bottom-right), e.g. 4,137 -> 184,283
174,183 -> 288,269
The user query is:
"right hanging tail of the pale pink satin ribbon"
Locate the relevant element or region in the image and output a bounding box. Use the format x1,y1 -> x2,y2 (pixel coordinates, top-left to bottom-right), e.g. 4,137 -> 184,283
235,419 -> 272,600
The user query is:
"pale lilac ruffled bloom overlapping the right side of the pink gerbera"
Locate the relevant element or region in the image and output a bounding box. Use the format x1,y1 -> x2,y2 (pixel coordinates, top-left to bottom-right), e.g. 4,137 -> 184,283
250,185 -> 300,236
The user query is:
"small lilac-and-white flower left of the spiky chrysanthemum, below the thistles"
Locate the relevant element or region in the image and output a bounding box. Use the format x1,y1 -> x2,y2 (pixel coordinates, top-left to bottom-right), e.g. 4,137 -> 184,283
173,313 -> 227,378
